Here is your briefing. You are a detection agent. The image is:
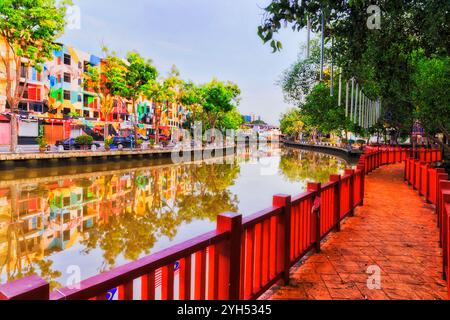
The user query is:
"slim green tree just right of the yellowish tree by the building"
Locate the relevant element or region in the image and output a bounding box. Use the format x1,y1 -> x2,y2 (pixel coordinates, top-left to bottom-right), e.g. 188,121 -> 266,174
123,52 -> 158,141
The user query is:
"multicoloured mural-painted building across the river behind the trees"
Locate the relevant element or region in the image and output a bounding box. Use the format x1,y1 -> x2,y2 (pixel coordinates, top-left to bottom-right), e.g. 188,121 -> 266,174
0,38 -> 184,145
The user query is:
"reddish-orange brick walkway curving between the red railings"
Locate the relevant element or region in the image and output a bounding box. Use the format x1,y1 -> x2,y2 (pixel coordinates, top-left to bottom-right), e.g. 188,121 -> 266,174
268,165 -> 448,300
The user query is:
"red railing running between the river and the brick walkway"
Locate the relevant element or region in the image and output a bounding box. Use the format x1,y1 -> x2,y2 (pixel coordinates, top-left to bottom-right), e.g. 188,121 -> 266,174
0,148 -> 450,300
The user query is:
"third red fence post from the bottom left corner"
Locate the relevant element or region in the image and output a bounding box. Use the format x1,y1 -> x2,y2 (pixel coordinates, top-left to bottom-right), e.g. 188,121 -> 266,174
273,195 -> 291,285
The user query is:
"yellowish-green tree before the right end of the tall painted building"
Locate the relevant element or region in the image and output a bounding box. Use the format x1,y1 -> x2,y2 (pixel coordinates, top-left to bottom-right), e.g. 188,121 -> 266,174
84,47 -> 127,139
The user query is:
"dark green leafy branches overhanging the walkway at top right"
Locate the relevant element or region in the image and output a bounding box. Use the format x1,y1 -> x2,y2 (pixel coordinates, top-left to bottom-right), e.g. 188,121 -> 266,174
258,0 -> 450,142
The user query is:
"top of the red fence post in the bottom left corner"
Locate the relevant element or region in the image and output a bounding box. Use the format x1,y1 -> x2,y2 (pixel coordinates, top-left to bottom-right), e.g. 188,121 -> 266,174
0,275 -> 50,300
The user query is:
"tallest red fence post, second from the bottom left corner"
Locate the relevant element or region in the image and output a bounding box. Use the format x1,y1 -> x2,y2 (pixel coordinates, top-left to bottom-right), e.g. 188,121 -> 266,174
217,212 -> 243,300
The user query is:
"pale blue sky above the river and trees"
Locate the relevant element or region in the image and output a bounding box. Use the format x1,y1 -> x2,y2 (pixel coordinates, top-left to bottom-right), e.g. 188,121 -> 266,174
60,0 -> 306,124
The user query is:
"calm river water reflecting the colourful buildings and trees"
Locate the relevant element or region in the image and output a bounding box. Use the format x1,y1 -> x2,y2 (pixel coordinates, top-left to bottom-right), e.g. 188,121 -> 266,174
0,147 -> 347,289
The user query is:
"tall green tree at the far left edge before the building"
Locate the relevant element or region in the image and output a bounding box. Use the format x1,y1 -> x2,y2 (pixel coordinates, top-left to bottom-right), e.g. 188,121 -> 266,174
0,0 -> 71,152
